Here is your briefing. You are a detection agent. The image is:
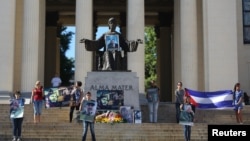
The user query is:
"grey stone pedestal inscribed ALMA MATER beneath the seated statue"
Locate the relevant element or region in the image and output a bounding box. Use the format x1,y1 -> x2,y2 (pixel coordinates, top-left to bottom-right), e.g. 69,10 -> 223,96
84,72 -> 140,110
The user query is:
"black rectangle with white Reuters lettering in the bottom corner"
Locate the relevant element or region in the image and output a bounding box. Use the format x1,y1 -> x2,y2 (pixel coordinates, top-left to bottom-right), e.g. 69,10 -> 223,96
208,125 -> 250,141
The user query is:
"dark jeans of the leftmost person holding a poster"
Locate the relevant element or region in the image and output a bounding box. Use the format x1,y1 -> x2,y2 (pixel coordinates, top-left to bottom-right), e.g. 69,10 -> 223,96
11,118 -> 23,137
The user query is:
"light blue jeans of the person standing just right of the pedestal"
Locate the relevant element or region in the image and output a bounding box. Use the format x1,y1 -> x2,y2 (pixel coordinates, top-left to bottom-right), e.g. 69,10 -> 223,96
148,102 -> 159,122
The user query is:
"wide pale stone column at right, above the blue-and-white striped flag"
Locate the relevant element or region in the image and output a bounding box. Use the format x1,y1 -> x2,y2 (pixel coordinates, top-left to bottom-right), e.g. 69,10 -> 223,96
200,0 -> 237,90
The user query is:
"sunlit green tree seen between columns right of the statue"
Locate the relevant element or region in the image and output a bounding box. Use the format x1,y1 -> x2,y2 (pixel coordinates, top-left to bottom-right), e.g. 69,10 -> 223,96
145,27 -> 157,88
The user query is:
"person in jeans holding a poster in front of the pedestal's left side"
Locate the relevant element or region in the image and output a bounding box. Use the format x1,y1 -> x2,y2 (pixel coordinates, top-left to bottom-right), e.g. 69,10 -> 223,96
79,92 -> 96,141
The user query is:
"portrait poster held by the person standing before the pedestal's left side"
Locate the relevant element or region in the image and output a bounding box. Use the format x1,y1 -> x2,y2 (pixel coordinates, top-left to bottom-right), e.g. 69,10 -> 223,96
80,100 -> 97,122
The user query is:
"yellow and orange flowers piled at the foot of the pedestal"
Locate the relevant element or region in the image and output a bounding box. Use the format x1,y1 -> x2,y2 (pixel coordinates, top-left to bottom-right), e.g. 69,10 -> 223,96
95,111 -> 124,124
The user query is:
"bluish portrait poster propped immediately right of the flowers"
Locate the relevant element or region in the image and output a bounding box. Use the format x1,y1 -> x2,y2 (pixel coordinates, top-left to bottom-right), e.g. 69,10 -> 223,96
120,106 -> 134,123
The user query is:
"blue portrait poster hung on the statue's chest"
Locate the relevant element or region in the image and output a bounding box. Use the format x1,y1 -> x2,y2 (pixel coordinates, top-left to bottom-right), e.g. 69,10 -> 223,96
105,35 -> 120,51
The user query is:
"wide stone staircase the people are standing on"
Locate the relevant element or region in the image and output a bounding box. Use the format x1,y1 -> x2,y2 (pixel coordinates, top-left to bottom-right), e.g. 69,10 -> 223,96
0,103 -> 250,141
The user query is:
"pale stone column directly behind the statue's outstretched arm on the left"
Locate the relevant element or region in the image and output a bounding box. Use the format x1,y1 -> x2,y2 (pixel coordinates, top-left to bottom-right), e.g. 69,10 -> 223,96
75,0 -> 93,85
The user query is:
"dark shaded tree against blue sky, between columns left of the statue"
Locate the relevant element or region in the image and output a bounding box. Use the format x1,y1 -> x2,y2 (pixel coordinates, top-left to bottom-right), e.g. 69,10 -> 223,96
57,26 -> 75,86
